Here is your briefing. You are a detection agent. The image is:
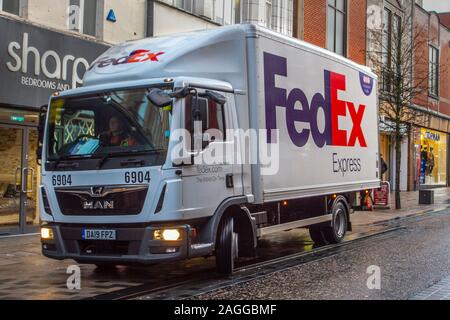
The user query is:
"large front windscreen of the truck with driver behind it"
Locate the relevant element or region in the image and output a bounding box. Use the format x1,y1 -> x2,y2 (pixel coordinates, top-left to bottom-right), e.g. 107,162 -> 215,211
47,88 -> 171,161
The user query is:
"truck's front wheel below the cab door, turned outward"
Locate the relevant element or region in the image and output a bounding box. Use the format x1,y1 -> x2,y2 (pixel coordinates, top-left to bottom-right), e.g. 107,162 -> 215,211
216,217 -> 238,275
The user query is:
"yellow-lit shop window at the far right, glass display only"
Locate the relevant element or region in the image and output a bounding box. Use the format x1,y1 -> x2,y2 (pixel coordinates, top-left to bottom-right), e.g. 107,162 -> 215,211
418,129 -> 447,185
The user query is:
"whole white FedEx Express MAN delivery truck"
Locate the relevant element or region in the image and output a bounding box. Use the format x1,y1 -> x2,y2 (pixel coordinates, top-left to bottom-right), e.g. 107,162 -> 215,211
40,24 -> 380,273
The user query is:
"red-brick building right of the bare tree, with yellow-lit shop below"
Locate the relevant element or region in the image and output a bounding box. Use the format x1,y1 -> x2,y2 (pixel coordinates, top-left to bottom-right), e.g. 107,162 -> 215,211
408,4 -> 450,189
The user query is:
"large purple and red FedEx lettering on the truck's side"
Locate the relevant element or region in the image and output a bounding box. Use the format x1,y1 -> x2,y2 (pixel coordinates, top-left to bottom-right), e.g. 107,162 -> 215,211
264,52 -> 367,148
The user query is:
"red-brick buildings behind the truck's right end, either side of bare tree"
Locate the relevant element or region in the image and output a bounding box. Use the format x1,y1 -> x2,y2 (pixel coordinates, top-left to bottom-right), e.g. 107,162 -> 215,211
293,0 -> 450,190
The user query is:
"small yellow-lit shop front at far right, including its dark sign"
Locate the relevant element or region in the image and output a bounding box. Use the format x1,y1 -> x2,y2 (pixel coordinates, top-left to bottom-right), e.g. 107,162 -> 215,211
414,128 -> 448,189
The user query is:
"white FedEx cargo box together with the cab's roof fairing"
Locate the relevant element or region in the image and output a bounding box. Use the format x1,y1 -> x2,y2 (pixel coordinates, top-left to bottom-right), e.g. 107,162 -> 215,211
84,24 -> 379,202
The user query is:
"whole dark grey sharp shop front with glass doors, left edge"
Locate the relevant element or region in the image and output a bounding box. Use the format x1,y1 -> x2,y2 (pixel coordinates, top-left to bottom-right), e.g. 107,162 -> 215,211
0,16 -> 108,236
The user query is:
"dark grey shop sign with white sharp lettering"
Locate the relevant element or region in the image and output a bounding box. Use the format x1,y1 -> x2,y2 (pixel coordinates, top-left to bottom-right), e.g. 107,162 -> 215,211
0,17 -> 108,108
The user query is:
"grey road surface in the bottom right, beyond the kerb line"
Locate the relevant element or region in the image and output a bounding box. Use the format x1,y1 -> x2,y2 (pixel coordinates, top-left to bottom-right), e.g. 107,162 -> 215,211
197,211 -> 450,299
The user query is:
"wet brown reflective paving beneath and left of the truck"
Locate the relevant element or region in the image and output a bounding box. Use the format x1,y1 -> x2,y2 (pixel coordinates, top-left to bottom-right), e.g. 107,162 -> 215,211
0,215 -> 400,299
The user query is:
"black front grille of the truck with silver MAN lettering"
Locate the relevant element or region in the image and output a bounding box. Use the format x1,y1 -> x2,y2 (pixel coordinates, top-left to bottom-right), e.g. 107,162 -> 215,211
55,185 -> 148,216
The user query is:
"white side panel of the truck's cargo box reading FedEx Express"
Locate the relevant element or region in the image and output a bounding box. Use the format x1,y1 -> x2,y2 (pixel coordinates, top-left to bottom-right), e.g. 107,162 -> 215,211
255,32 -> 379,201
